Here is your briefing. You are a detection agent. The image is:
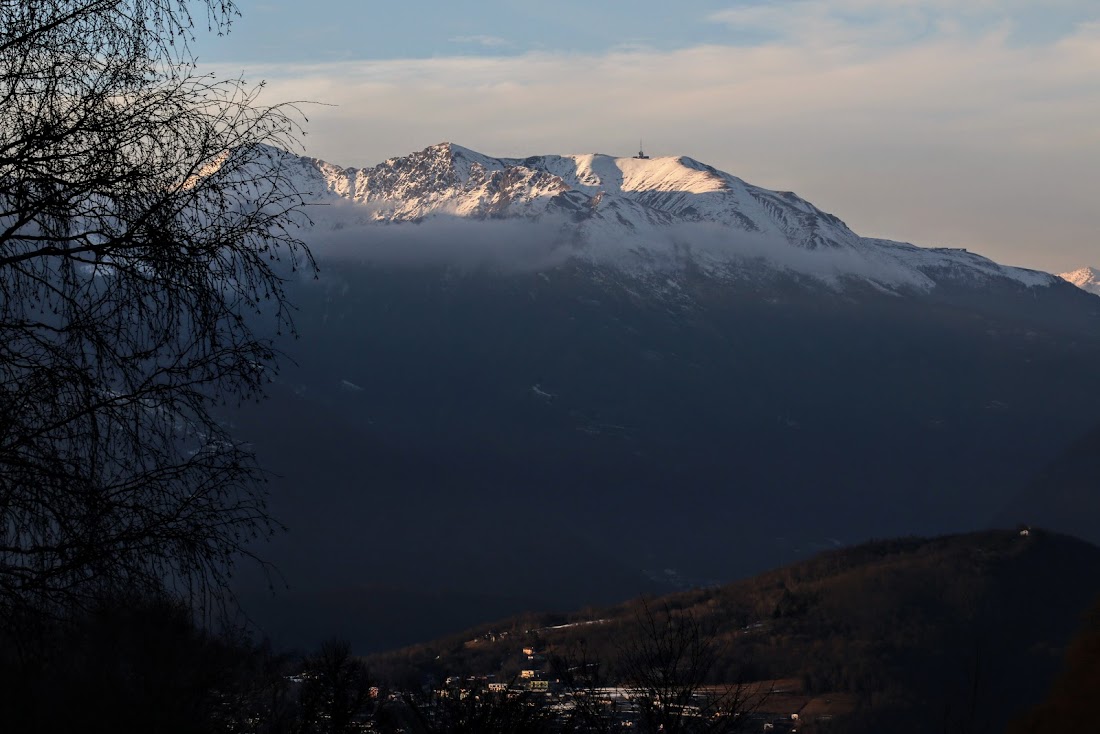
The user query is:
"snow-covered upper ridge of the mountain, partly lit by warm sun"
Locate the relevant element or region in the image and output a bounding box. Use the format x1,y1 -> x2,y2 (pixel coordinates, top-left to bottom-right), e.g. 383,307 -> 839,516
259,143 -> 1056,291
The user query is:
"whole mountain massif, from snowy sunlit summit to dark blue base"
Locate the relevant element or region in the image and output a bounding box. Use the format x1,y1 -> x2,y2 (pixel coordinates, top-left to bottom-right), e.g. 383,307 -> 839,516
227,144 -> 1100,649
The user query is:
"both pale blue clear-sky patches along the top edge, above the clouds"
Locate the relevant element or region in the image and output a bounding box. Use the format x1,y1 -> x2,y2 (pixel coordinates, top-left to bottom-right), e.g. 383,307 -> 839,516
200,0 -> 1082,63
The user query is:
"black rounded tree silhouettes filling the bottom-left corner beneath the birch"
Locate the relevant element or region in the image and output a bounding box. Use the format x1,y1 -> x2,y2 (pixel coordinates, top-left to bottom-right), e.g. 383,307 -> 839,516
0,593 -> 404,734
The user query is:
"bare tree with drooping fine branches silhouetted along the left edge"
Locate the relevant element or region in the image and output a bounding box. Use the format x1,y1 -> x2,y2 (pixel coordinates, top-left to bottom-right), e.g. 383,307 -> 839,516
0,0 -> 314,614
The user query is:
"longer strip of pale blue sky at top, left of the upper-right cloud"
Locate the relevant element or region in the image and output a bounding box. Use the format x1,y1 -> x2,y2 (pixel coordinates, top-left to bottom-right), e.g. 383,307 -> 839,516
195,0 -> 756,62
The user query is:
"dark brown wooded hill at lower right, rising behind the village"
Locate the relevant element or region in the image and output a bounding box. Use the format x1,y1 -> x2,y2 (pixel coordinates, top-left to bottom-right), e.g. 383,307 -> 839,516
369,527 -> 1100,733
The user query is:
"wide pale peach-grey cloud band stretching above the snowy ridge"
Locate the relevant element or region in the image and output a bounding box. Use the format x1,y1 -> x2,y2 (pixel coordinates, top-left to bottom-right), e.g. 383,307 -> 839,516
218,14 -> 1100,270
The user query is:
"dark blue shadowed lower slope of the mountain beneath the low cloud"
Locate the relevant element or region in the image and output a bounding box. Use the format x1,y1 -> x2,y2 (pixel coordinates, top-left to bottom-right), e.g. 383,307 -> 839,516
231,262 -> 1100,647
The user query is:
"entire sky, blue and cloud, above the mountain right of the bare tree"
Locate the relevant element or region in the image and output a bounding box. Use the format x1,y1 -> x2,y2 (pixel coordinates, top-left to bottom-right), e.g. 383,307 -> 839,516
194,0 -> 1100,272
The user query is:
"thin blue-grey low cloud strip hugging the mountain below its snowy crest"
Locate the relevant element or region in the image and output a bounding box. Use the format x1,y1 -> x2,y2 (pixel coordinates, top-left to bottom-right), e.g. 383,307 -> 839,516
297,204 -> 1025,289
